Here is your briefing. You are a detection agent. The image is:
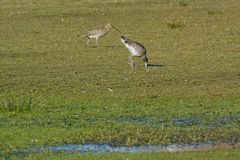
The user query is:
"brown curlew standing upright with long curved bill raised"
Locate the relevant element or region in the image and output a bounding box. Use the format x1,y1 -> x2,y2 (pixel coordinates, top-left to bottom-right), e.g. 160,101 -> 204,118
82,23 -> 121,46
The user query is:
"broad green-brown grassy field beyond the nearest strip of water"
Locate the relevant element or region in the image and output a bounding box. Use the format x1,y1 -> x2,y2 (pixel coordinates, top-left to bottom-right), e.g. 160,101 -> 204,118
0,0 -> 240,159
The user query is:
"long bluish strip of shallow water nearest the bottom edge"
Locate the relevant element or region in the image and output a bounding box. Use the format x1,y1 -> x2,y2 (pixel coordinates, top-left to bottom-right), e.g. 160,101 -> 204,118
14,142 -> 240,156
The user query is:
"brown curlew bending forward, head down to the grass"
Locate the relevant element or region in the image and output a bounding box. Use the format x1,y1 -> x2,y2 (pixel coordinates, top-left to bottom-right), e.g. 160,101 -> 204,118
121,36 -> 148,67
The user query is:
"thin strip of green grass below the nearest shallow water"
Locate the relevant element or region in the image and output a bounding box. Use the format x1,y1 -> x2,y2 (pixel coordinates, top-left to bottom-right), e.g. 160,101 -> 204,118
3,148 -> 240,160
